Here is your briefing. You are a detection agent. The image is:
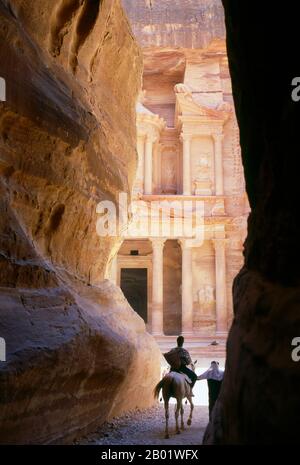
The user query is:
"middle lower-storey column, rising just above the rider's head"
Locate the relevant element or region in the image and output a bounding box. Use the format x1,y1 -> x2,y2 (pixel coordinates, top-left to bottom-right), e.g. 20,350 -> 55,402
180,239 -> 193,335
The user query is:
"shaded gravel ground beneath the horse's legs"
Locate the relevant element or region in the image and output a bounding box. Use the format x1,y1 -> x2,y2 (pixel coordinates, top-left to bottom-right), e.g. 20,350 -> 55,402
75,404 -> 208,445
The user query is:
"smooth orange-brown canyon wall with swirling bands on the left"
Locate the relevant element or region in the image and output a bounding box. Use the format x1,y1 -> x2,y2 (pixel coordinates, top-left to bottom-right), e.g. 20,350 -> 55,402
0,0 -> 160,443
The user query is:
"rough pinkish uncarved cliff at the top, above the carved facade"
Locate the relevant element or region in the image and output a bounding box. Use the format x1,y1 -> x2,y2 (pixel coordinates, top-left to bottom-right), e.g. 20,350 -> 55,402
122,0 -> 225,48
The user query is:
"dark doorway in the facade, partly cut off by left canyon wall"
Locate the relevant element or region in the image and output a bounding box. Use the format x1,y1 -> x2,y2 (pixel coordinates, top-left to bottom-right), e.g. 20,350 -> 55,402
121,268 -> 148,323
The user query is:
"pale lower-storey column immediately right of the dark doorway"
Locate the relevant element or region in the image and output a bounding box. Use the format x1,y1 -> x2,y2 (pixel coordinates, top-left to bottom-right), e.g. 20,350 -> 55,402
151,239 -> 165,335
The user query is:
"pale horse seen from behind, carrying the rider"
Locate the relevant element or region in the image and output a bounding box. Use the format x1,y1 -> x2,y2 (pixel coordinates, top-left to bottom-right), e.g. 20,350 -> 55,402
154,365 -> 195,439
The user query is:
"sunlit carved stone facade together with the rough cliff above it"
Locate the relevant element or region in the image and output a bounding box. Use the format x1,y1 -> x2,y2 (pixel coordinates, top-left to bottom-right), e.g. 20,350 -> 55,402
115,0 -> 249,359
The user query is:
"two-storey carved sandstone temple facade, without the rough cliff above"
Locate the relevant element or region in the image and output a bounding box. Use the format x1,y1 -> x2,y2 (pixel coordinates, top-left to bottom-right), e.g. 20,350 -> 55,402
111,40 -> 249,354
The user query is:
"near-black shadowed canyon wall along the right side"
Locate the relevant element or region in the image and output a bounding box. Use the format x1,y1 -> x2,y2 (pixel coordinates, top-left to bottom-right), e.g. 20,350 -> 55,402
205,0 -> 300,444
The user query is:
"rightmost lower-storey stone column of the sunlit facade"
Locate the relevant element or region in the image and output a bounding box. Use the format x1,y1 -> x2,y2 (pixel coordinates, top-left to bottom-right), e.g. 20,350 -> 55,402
213,239 -> 227,335
